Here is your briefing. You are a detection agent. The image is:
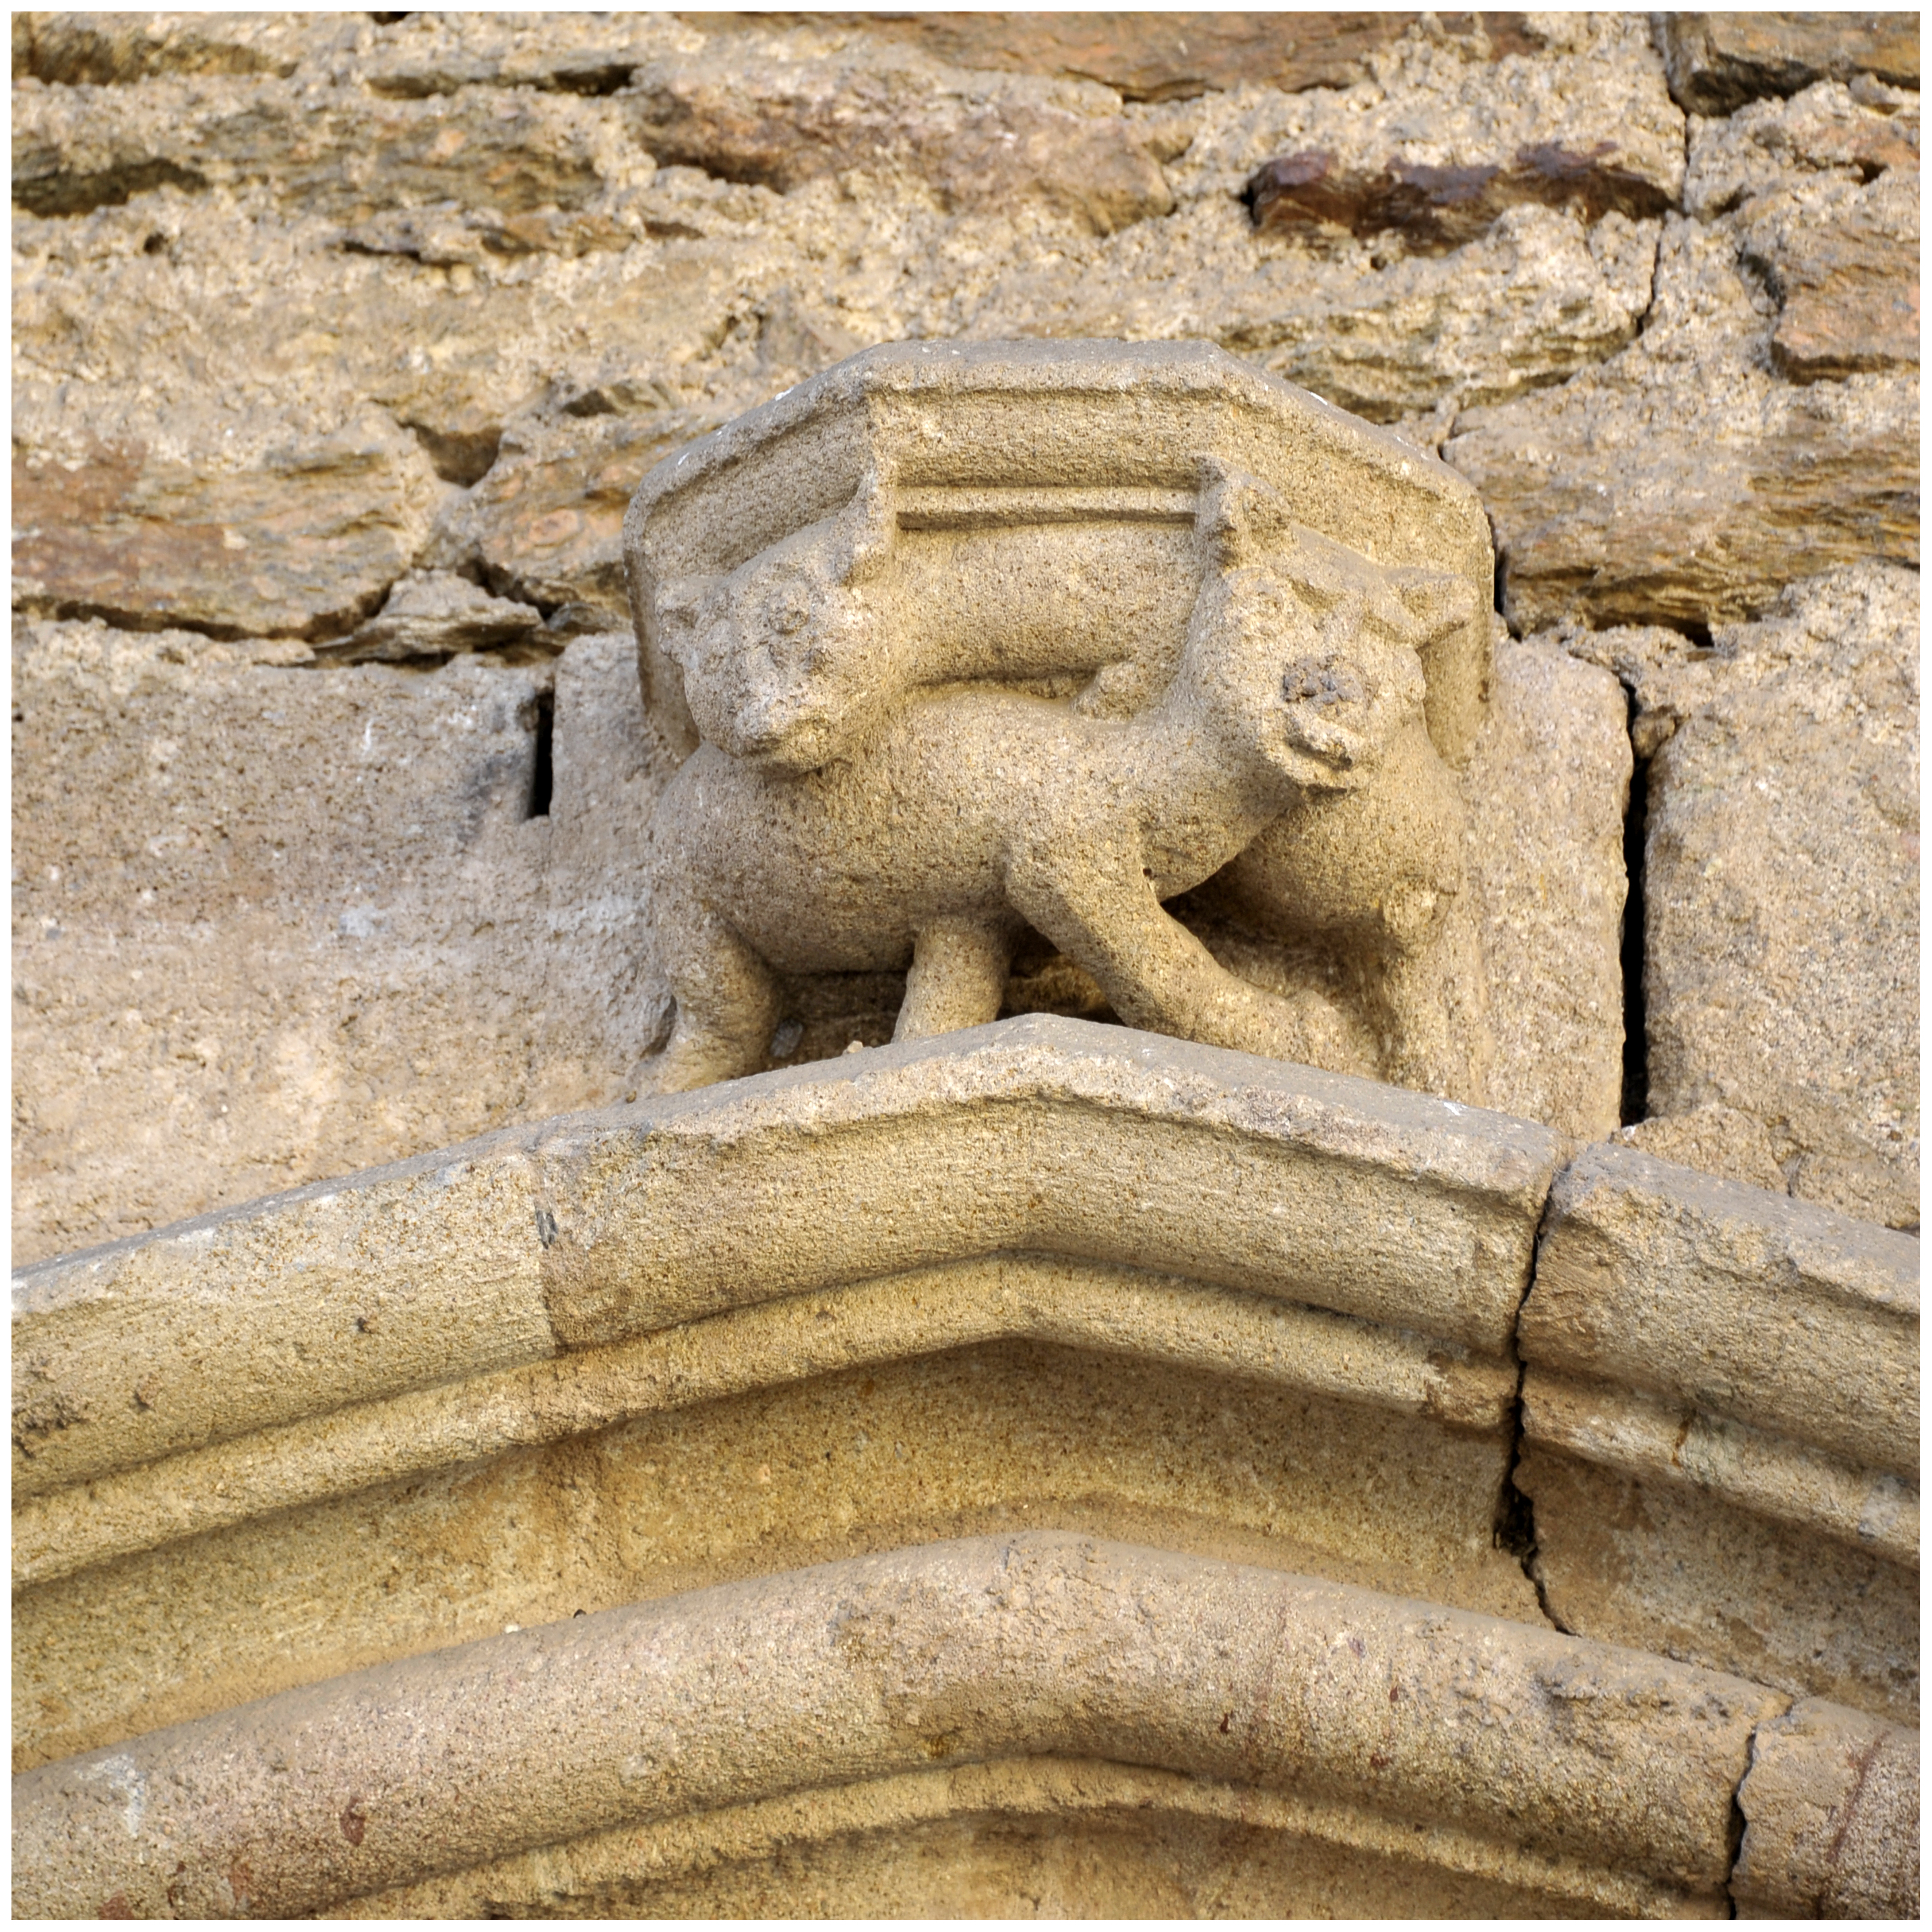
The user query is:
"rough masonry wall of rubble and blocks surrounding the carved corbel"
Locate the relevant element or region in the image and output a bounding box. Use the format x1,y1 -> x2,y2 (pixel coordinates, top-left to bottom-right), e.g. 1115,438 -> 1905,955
13,13 -> 1919,1259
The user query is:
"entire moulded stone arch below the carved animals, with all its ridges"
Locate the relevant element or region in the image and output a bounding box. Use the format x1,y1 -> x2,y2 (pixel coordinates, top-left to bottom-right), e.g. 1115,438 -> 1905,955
13,1016 -> 1917,1914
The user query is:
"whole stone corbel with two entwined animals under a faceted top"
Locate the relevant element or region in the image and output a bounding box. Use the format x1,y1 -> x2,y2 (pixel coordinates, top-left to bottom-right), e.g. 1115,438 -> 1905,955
626,344 -> 1489,1101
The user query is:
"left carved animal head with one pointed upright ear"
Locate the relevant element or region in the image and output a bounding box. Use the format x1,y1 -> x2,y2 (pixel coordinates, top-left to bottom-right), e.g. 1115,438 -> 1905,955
676,472 -> 896,771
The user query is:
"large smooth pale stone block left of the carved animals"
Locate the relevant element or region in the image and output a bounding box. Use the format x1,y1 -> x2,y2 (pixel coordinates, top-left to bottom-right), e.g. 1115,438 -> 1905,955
13,624 -> 672,1259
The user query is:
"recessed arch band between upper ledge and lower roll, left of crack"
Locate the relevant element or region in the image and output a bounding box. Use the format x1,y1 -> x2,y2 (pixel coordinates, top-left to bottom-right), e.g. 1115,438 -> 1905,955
15,1336 -> 1540,1768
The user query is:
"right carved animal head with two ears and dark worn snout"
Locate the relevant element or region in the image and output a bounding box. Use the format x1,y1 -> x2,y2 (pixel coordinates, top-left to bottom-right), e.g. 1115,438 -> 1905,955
1188,470 -> 1476,790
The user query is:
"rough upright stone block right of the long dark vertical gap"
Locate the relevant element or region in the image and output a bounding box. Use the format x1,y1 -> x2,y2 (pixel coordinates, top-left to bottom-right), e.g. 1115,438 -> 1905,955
1571,566 -> 1919,1227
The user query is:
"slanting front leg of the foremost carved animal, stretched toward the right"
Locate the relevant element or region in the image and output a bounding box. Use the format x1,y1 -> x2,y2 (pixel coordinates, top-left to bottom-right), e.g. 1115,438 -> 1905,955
1007,854 -> 1306,1061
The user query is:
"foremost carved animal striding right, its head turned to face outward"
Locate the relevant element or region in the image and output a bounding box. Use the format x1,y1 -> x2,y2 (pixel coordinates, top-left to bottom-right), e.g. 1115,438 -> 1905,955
644,475 -> 1468,1092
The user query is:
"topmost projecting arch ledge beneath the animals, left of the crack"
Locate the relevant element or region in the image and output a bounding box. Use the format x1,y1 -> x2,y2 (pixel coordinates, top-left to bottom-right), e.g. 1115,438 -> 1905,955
13,1014 -> 1557,1497
